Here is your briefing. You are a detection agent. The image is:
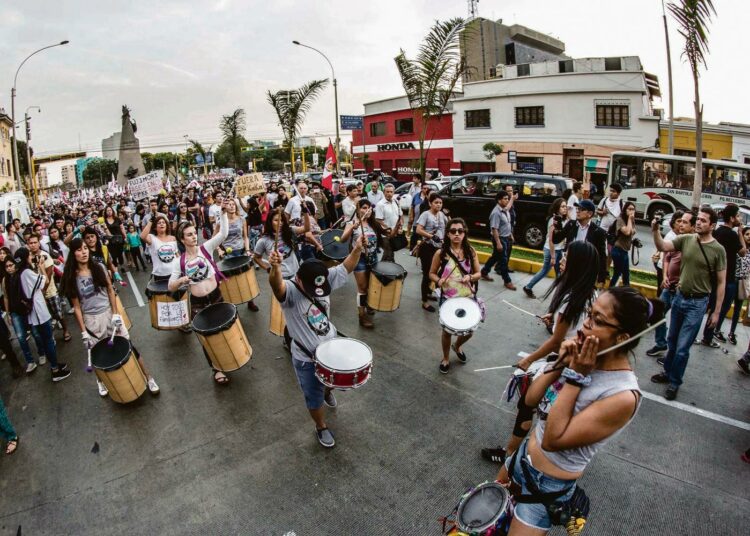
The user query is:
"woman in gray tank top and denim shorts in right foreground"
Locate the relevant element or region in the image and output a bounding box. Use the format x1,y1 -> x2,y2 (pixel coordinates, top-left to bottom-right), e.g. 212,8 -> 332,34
498,287 -> 664,536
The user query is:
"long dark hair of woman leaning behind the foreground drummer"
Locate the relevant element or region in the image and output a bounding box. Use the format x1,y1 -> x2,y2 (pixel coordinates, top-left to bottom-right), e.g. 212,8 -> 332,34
544,240 -> 599,324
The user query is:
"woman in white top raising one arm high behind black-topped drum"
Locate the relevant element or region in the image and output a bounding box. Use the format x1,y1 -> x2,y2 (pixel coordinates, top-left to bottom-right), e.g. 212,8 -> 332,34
169,200 -> 233,385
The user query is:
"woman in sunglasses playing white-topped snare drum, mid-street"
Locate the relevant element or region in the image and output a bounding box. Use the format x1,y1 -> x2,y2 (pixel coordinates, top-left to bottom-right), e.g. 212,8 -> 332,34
428,217 -> 482,374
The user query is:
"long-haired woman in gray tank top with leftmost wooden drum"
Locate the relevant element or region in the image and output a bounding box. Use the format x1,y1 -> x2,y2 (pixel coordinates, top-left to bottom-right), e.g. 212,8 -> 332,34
62,238 -> 159,396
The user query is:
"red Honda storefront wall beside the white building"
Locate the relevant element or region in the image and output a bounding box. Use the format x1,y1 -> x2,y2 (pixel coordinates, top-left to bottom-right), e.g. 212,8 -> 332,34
352,109 -> 461,176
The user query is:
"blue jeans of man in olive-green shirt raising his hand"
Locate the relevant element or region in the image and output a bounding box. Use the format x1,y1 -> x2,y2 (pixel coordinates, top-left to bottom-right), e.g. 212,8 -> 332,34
664,290 -> 708,387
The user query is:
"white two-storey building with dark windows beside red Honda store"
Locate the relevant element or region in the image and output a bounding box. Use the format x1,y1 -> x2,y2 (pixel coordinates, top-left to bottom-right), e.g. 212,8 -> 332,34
453,56 -> 659,191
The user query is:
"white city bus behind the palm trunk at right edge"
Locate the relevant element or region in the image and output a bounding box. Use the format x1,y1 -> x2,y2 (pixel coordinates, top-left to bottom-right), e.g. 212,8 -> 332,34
605,151 -> 750,220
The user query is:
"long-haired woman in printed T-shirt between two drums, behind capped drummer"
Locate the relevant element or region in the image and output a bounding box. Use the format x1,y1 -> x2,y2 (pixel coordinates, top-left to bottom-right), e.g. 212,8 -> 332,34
341,198 -> 385,328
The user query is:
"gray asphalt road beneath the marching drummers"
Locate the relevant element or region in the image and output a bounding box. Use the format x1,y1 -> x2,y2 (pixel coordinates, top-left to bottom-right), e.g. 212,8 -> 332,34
0,256 -> 750,536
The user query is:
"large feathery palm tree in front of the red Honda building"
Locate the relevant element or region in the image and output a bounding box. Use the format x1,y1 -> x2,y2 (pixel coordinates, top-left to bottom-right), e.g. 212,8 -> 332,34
395,18 -> 467,177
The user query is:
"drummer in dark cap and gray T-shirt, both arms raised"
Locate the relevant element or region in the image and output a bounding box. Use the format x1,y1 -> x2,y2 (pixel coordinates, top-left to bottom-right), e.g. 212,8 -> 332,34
268,234 -> 365,448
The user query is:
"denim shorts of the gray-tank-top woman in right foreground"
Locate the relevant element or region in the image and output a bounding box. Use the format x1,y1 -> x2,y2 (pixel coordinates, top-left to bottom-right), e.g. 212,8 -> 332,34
505,440 -> 576,530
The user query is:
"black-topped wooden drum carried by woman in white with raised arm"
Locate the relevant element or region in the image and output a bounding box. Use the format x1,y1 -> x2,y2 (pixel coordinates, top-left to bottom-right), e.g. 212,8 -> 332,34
193,302 -> 253,372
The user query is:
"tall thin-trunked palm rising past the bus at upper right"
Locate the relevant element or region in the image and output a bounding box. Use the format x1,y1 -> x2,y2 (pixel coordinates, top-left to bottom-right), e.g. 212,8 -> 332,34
667,0 -> 716,210
